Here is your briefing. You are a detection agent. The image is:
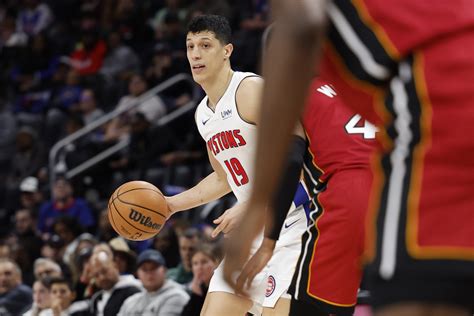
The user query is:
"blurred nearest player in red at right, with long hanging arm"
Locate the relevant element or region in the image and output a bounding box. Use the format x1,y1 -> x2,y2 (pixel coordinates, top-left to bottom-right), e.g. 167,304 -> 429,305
225,0 -> 474,315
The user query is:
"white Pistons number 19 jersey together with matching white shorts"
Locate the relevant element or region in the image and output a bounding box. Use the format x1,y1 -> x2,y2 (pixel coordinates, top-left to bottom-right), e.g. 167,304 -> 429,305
195,72 -> 309,308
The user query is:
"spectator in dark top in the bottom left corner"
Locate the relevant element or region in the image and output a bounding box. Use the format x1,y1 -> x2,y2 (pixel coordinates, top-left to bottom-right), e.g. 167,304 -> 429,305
0,259 -> 33,315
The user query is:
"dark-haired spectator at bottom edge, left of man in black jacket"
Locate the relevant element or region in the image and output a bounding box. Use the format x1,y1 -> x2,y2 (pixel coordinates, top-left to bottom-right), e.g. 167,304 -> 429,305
41,278 -> 89,316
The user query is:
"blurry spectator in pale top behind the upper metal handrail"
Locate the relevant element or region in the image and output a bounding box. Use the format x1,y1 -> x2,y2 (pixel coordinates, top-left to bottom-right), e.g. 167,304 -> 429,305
105,74 -> 166,141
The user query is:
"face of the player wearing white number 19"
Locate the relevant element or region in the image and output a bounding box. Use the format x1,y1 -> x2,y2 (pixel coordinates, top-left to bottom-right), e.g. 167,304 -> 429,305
186,31 -> 232,84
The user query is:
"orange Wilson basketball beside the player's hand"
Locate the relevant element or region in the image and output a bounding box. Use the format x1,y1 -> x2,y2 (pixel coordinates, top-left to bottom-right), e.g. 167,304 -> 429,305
108,181 -> 170,240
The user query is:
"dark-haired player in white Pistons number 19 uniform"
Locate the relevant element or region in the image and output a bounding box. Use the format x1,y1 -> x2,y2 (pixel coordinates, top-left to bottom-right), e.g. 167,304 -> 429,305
166,15 -> 308,316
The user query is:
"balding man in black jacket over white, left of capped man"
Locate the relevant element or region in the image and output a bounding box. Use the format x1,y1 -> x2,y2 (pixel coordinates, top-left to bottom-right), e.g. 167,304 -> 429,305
90,250 -> 141,316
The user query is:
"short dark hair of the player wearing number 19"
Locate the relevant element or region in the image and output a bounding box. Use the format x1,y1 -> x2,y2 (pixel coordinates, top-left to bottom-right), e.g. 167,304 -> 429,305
187,14 -> 232,45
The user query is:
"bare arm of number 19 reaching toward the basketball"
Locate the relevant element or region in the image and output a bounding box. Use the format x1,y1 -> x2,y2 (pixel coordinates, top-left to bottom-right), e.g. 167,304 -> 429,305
166,150 -> 231,213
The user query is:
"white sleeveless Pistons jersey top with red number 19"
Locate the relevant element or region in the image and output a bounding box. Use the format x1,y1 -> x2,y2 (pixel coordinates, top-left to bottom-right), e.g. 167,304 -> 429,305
195,71 -> 258,202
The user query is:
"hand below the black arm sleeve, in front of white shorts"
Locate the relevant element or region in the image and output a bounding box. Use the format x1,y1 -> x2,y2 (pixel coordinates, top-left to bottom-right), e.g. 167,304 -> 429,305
235,237 -> 276,293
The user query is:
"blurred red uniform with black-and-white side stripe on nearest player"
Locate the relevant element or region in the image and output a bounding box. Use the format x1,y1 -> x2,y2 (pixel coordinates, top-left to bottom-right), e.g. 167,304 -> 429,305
320,0 -> 474,266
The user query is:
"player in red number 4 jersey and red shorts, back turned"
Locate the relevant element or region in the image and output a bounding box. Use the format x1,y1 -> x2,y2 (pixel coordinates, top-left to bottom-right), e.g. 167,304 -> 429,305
237,78 -> 376,316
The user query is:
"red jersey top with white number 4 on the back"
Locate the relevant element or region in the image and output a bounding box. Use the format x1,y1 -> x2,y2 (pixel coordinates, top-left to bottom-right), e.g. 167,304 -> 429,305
302,79 -> 376,193
